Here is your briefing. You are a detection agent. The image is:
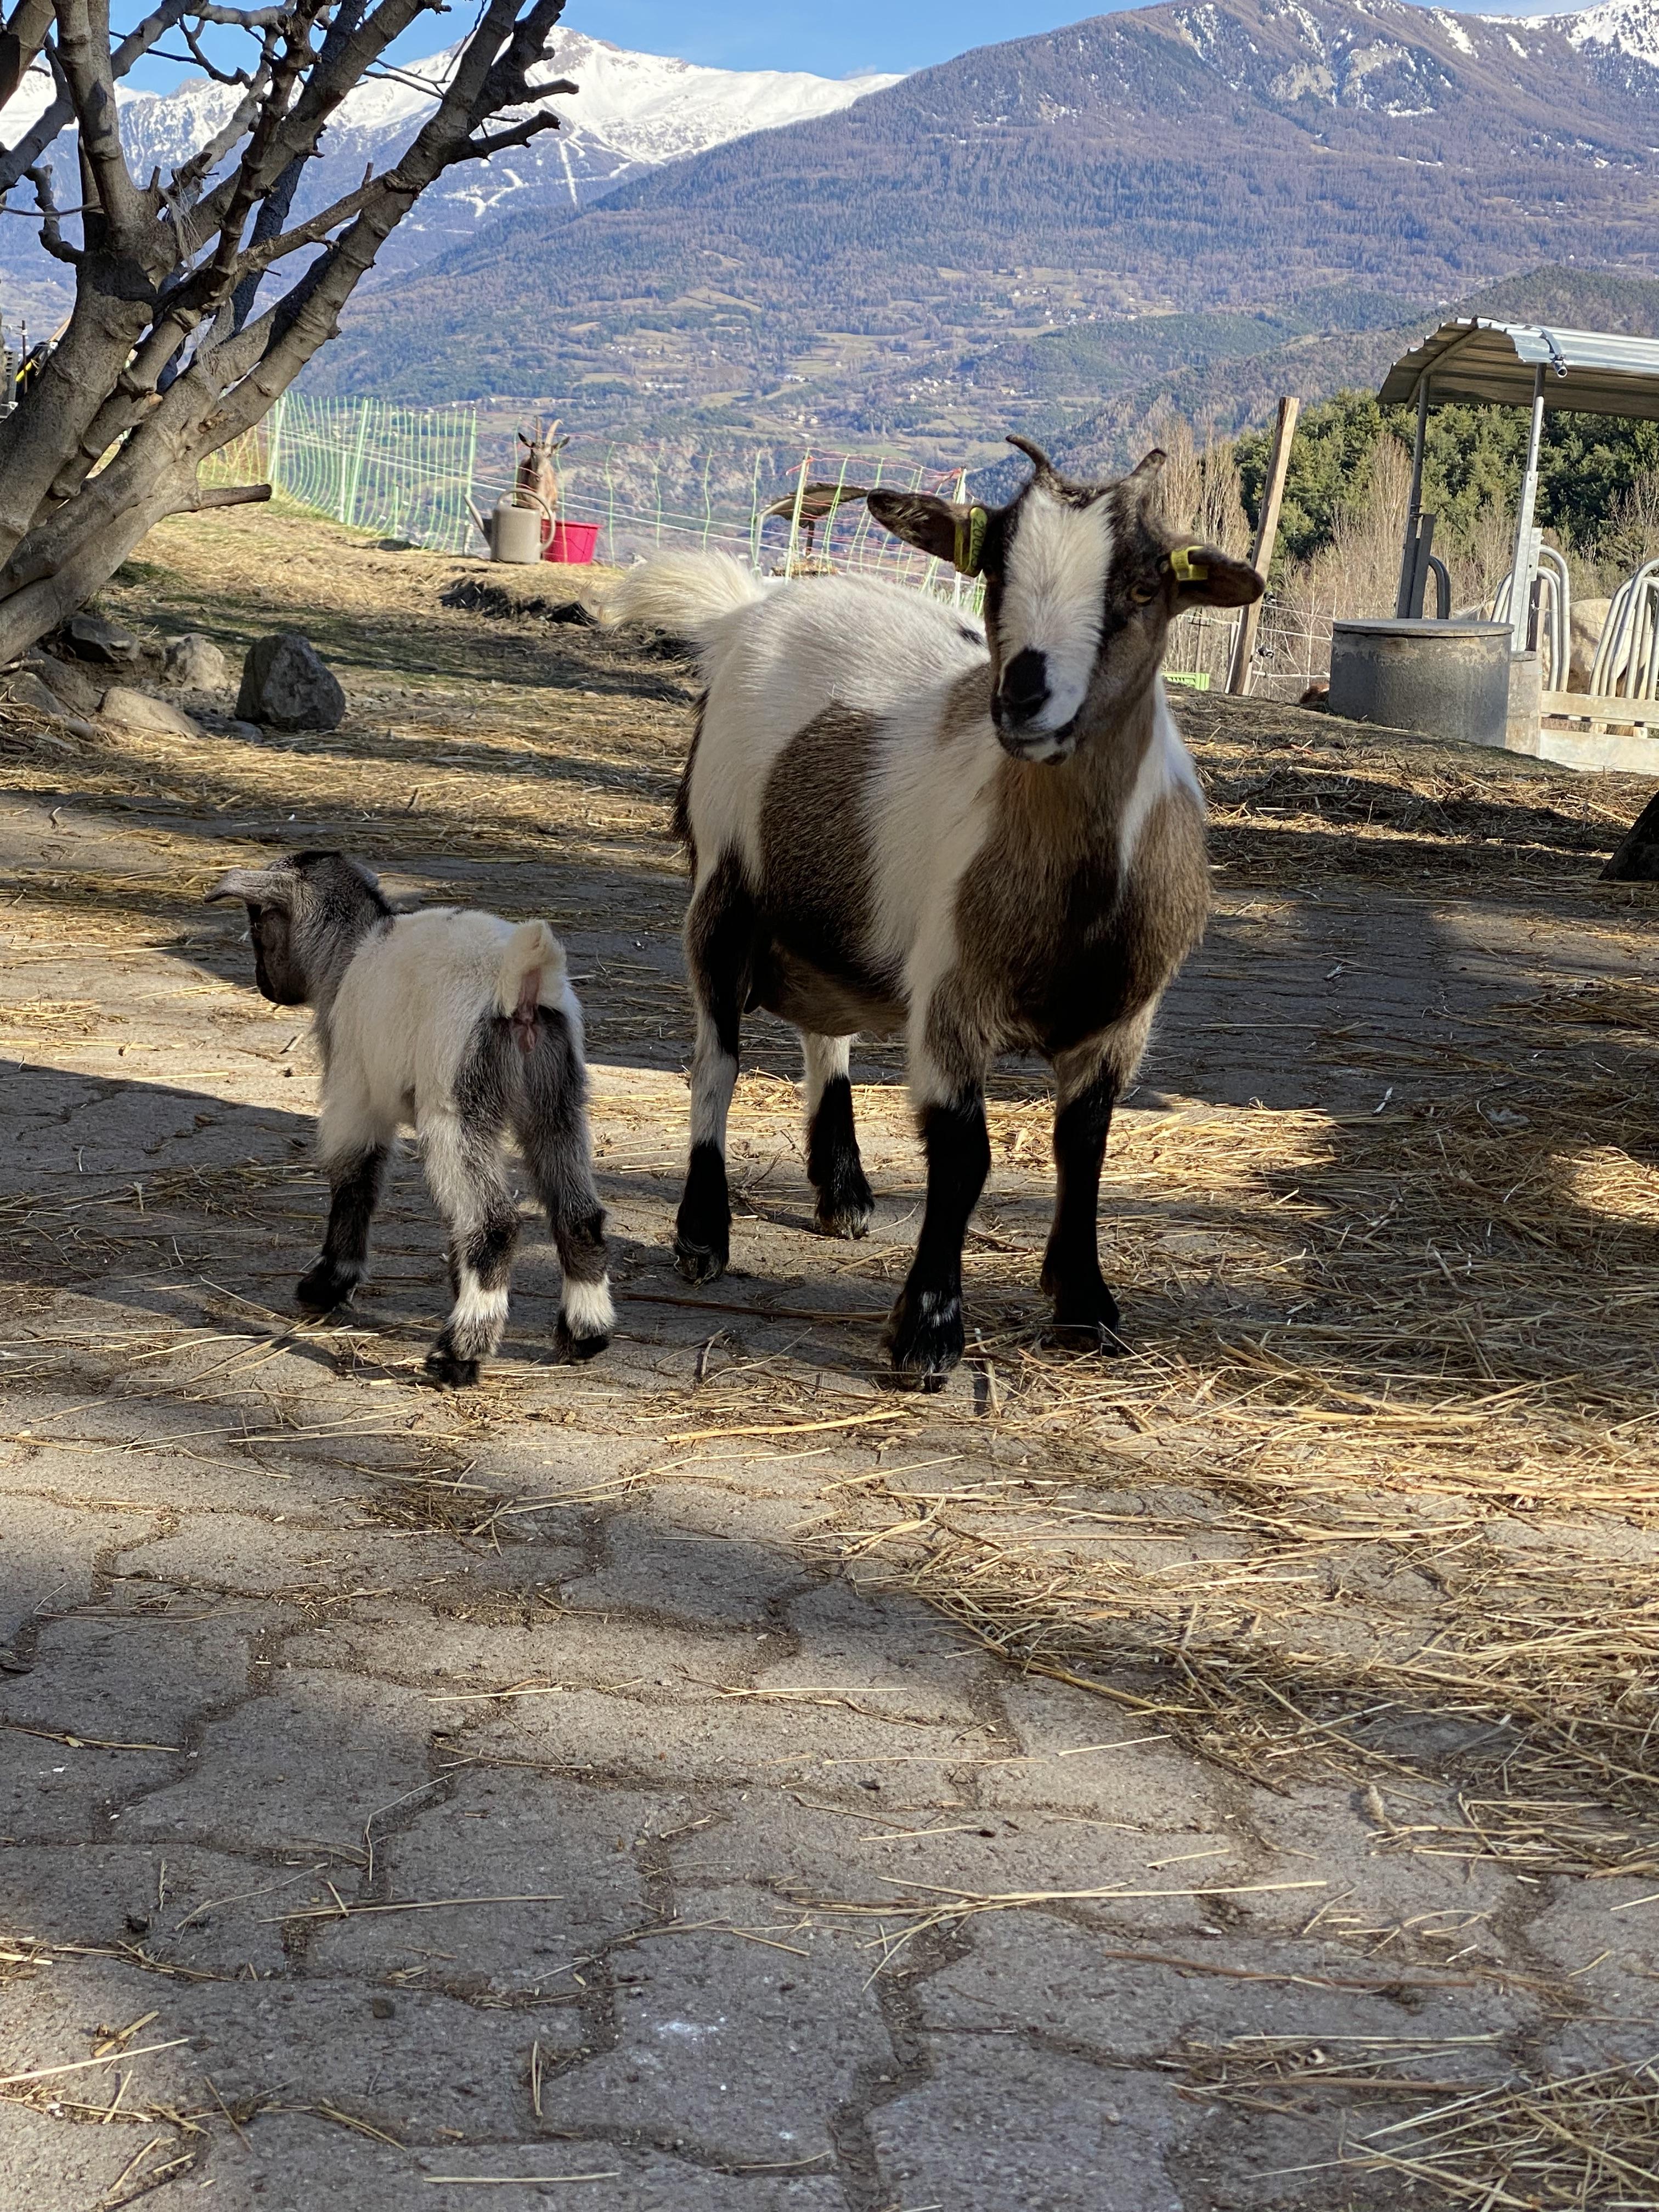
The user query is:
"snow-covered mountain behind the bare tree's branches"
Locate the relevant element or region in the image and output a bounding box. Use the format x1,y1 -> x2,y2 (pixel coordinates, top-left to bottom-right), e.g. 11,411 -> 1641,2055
0,31 -> 898,314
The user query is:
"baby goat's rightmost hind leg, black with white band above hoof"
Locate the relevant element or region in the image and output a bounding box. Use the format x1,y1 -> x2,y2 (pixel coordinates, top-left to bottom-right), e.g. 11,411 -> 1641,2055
513,1007 -> 615,1361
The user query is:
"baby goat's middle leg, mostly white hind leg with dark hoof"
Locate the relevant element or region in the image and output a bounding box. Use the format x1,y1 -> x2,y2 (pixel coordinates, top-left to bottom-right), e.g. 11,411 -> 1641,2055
420,1088 -> 517,1385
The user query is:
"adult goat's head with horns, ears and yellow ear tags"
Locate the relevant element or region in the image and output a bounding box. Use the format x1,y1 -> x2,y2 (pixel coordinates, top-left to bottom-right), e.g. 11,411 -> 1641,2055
865,438 -> 1263,763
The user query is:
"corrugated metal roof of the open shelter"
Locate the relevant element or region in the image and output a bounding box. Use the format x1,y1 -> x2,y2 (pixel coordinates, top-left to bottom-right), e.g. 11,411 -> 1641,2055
1378,317 -> 1659,422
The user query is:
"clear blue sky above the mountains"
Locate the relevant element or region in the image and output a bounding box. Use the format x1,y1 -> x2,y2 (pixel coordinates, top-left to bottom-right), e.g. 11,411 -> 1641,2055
113,0 -> 1583,93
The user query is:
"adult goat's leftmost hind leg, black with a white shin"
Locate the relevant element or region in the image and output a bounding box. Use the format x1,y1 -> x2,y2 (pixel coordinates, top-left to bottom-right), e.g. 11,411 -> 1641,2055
675,854 -> 754,1283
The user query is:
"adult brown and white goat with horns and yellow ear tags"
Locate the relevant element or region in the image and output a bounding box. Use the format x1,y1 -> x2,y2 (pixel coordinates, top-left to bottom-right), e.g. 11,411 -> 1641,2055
611,438 -> 1261,1387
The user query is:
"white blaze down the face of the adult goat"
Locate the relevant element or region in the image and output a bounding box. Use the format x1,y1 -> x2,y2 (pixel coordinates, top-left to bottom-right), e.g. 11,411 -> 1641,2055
997,484 -> 1113,735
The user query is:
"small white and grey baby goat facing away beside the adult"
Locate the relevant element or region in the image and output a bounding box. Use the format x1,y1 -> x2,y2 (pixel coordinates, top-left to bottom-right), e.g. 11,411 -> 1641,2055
208,851 -> 611,1383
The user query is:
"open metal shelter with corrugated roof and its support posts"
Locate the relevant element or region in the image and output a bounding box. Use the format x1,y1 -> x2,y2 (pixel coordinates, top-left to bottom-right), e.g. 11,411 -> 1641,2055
1378,317 -> 1659,652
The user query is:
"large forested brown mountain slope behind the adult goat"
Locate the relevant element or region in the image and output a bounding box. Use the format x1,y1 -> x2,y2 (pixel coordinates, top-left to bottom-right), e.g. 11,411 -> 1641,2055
305,0 -> 1659,444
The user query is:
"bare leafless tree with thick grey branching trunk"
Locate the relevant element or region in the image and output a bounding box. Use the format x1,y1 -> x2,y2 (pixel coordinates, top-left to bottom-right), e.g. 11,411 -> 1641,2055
0,0 -> 575,666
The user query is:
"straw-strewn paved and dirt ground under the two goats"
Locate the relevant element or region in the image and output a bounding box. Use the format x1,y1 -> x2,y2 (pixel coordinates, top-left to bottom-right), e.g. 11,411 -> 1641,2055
0,513 -> 1659,2212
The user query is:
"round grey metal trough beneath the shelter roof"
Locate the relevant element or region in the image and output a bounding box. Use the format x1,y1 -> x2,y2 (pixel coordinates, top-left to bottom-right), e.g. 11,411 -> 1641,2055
1329,622 -> 1513,746
